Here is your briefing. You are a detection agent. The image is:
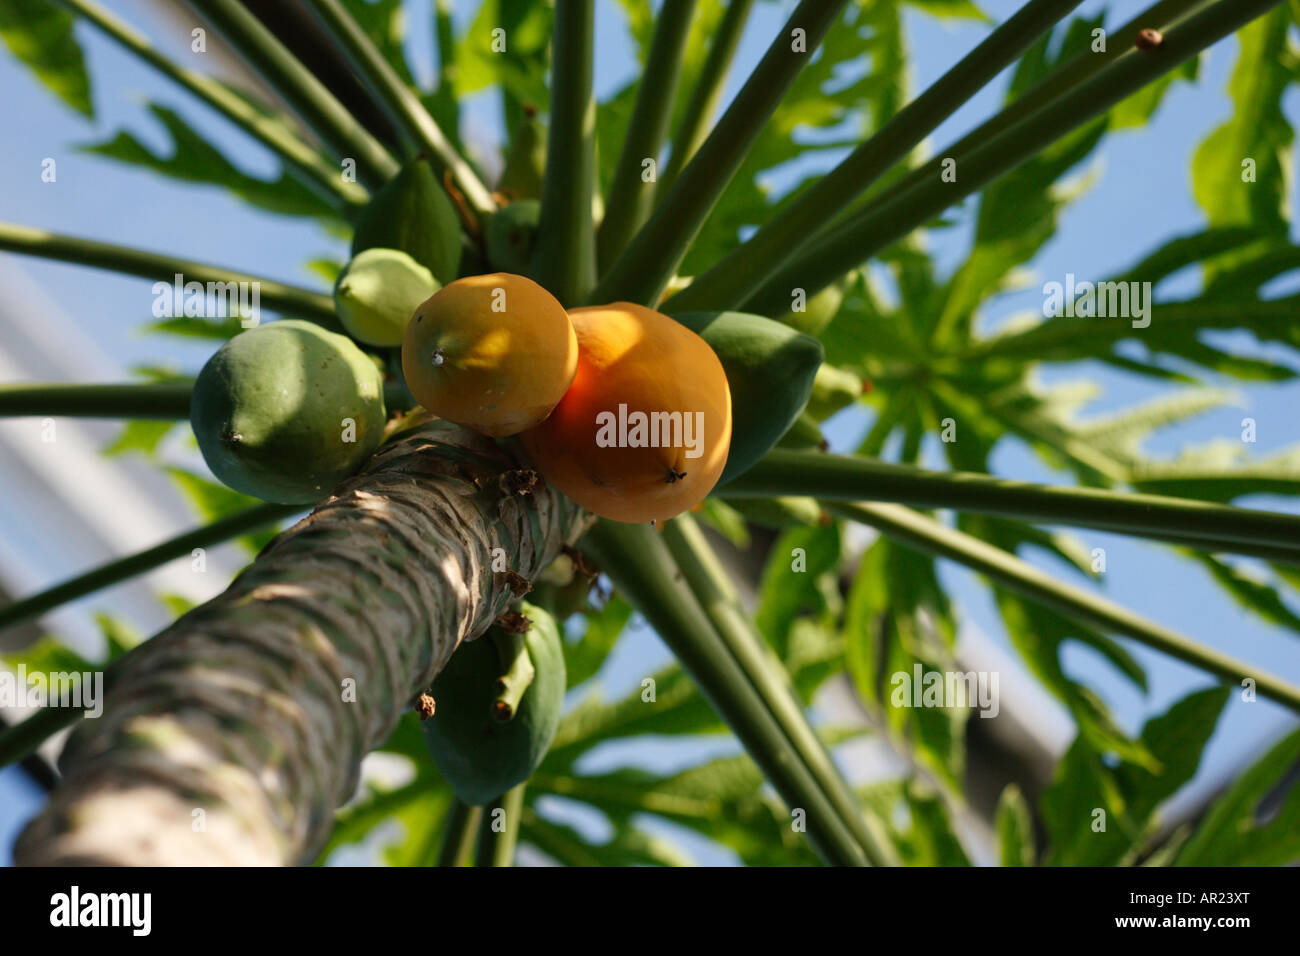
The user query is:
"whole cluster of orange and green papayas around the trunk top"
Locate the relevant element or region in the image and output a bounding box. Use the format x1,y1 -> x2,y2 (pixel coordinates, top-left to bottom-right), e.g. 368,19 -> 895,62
191,108 -> 844,804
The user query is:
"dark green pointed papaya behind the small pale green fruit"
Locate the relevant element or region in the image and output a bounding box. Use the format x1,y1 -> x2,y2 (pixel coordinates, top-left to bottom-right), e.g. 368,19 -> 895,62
352,157 -> 460,285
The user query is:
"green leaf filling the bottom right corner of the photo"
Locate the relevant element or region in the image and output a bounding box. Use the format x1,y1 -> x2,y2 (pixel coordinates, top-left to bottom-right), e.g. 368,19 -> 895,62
1174,731 -> 1300,866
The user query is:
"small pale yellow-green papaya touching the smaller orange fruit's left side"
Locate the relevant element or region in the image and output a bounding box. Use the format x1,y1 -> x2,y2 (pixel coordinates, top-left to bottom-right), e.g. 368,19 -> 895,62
334,246 -> 442,346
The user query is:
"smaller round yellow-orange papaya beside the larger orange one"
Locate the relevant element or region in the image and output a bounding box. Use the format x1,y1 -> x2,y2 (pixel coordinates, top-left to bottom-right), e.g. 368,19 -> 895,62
402,272 -> 577,438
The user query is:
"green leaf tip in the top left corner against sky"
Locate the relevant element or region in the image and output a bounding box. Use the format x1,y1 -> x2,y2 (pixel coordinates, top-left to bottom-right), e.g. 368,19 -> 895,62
0,0 -> 95,117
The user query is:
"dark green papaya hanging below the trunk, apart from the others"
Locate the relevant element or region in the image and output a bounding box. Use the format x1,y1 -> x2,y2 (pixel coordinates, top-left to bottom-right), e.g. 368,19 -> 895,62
420,604 -> 566,806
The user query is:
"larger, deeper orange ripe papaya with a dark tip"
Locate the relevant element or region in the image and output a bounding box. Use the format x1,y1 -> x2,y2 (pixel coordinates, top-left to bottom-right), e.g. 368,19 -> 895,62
520,302 -> 732,522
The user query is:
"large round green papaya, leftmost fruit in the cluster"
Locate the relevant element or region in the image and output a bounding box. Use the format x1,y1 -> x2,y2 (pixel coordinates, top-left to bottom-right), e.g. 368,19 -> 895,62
190,319 -> 386,505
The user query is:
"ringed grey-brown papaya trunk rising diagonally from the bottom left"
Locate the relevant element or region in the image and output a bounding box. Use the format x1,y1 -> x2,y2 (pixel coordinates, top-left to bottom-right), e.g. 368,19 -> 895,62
14,421 -> 586,865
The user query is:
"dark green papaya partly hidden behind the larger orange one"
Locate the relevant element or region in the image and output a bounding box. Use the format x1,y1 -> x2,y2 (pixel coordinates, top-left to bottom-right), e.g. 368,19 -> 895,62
673,312 -> 824,488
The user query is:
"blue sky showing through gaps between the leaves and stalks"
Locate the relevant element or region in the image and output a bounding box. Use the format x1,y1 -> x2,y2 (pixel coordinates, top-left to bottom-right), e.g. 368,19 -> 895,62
0,0 -> 1300,861
